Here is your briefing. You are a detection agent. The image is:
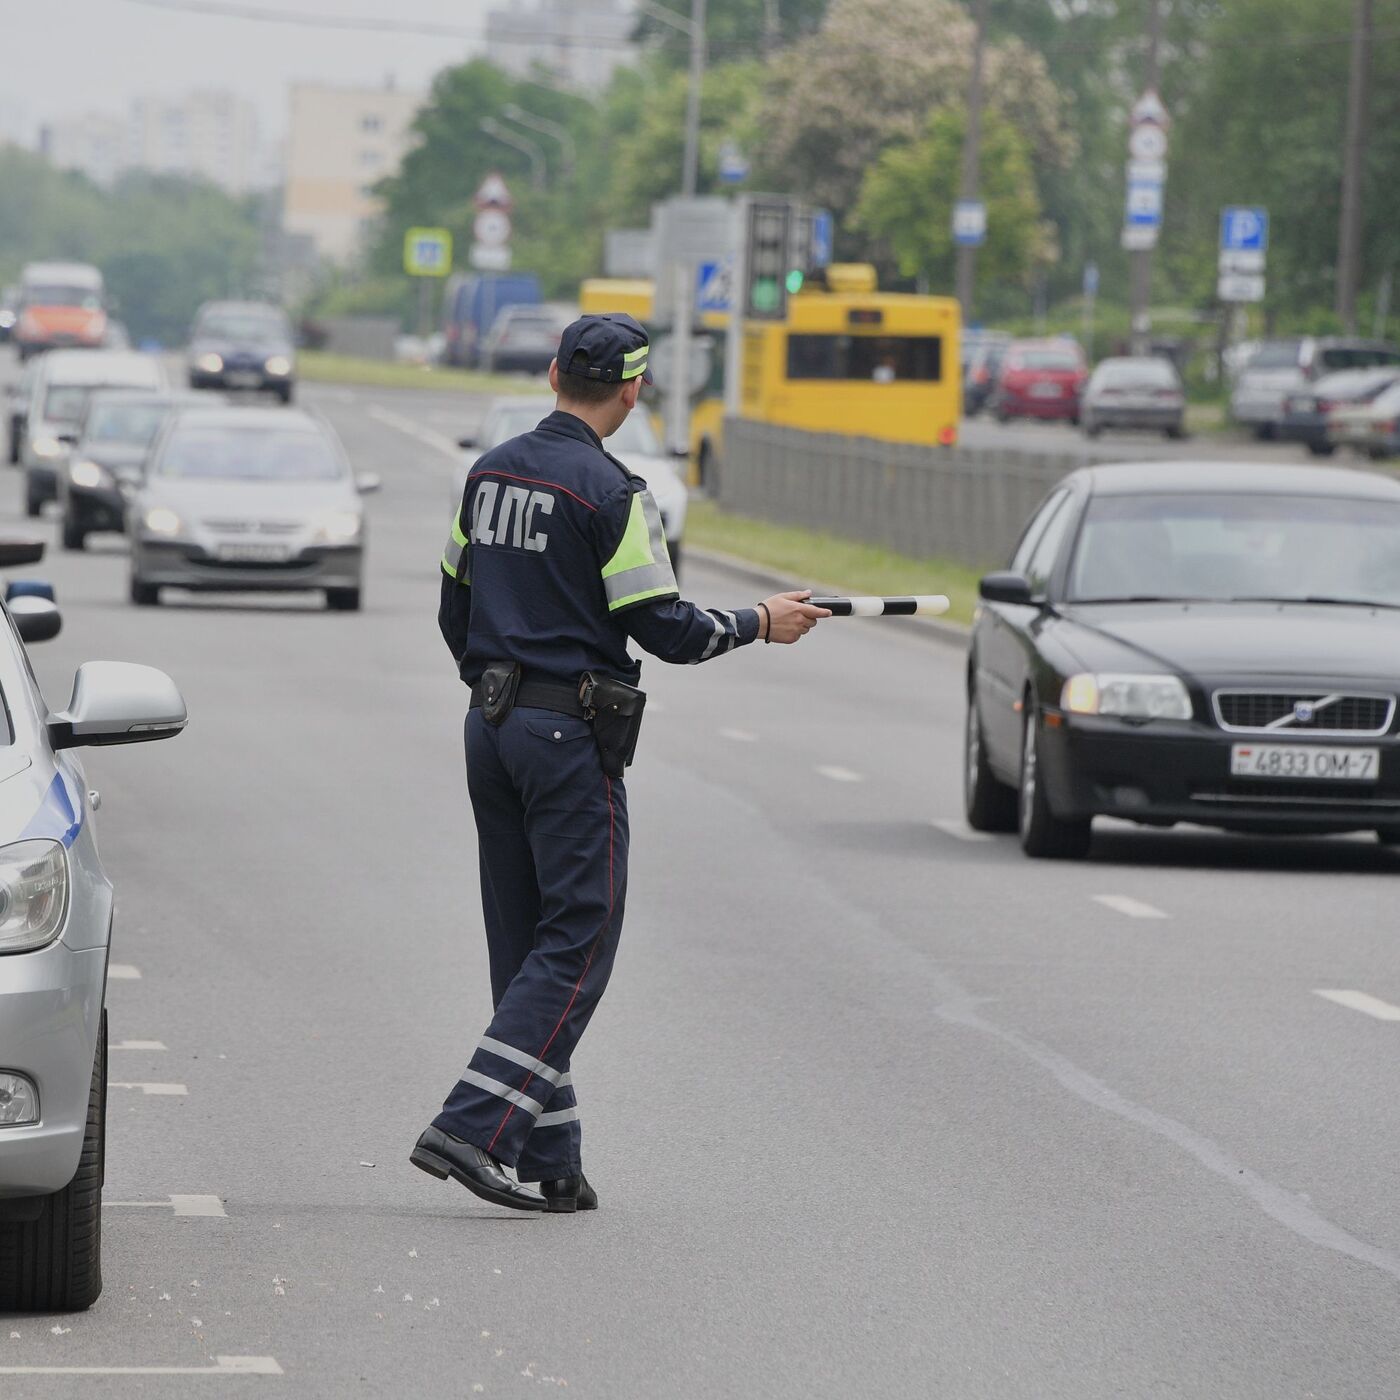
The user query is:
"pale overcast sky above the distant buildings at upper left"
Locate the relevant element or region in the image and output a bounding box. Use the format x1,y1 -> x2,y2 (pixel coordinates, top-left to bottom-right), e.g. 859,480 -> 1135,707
0,0 -> 498,136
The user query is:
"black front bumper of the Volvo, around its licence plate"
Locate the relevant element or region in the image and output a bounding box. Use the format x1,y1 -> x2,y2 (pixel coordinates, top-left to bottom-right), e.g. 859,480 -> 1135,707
1040,711 -> 1400,832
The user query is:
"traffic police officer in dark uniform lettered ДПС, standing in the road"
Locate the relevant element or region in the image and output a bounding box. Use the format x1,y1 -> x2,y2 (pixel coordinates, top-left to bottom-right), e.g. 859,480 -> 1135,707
412,315 -> 829,1211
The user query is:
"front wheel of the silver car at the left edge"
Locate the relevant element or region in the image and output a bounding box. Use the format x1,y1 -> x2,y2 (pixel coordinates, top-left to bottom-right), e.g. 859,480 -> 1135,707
0,1011 -> 106,1312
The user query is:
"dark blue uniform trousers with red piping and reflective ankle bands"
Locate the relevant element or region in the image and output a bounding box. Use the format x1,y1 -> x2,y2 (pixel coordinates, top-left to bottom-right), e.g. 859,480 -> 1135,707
434,708 -> 627,1182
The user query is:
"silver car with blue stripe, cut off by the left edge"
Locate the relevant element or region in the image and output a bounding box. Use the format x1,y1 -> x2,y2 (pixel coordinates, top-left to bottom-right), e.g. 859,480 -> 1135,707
0,545 -> 186,1312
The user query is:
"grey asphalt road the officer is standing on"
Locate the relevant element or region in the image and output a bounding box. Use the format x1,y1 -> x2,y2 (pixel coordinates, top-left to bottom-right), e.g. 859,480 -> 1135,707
0,355 -> 1400,1400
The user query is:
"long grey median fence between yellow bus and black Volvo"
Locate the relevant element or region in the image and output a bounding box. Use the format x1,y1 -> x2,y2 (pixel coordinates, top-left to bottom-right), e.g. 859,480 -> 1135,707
717,419 -> 1085,568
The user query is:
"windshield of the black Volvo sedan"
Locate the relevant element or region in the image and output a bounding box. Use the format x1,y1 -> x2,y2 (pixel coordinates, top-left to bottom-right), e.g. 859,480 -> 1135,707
1068,493 -> 1400,608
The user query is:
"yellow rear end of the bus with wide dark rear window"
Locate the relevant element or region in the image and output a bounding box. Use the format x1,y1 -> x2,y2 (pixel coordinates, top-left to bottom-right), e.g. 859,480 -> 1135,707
739,267 -> 962,447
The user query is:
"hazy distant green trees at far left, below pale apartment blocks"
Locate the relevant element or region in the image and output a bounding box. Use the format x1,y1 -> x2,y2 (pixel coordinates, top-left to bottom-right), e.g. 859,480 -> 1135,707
0,147 -> 260,344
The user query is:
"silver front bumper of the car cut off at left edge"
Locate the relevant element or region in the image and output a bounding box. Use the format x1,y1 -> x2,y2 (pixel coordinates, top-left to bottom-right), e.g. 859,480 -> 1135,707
0,939 -> 106,1198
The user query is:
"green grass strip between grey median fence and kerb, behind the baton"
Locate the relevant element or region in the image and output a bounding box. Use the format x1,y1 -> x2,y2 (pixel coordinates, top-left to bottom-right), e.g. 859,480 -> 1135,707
686,500 -> 981,623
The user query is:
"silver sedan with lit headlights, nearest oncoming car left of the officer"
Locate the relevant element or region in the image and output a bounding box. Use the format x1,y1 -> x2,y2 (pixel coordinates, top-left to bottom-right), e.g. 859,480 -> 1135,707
127,407 -> 379,612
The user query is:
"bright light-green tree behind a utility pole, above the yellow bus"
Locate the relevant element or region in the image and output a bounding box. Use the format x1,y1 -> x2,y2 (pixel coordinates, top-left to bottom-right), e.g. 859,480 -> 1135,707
854,109 -> 1054,307
